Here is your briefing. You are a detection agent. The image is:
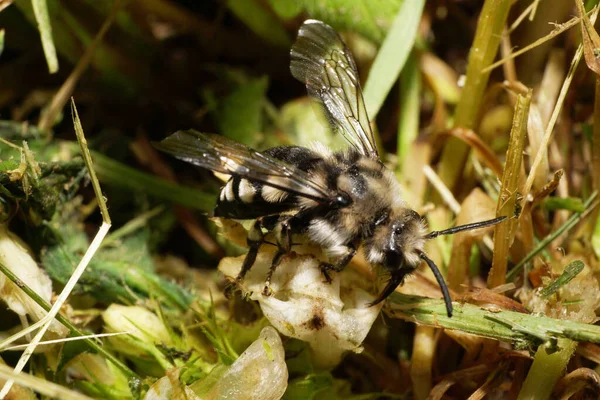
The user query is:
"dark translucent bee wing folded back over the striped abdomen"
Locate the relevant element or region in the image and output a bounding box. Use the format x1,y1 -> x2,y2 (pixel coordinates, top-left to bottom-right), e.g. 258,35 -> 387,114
154,130 -> 334,203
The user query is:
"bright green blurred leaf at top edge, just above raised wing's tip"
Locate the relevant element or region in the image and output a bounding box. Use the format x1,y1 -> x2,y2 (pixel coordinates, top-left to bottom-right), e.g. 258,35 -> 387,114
302,0 -> 400,43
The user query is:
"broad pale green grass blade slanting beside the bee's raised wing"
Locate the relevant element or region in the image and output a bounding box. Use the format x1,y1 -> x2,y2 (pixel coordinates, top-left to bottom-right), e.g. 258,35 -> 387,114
364,0 -> 425,120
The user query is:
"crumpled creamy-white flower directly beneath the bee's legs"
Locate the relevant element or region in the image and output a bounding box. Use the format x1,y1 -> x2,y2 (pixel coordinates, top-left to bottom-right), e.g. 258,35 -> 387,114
219,220 -> 381,368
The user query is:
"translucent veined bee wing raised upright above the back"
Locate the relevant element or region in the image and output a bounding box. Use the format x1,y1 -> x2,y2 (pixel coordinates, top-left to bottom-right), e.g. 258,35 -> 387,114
290,19 -> 379,158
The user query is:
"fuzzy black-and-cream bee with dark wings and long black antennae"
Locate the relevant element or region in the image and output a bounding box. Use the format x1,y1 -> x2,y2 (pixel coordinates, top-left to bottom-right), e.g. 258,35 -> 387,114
155,20 -> 504,316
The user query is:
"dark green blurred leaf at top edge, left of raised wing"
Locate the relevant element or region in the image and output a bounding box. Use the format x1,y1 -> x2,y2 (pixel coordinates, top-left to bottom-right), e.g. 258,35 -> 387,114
227,0 -> 292,48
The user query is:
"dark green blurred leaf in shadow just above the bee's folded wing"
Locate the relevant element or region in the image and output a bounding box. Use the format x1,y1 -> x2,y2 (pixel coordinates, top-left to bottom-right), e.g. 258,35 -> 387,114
216,77 -> 269,147
